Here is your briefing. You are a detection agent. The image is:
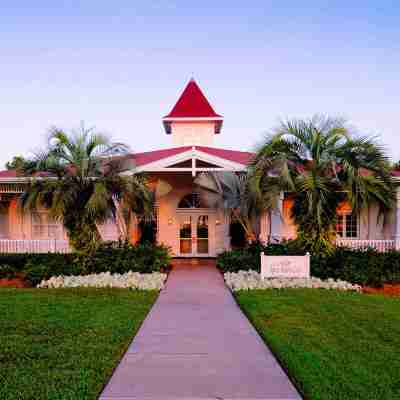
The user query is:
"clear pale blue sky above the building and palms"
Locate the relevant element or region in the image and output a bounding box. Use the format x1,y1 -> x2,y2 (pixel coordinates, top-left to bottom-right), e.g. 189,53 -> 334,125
0,0 -> 400,168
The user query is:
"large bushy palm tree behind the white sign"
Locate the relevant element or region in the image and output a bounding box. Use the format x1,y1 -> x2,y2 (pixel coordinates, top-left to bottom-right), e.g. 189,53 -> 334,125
250,116 -> 396,252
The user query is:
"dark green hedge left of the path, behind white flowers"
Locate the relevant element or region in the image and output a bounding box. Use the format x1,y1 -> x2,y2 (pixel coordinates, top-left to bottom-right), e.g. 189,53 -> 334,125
0,243 -> 171,286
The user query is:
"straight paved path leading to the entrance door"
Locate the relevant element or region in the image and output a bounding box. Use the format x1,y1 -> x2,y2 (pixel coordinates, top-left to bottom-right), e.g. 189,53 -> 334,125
100,265 -> 301,400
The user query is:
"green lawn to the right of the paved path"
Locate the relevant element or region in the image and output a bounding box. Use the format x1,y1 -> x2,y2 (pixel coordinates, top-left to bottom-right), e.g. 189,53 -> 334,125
236,289 -> 400,400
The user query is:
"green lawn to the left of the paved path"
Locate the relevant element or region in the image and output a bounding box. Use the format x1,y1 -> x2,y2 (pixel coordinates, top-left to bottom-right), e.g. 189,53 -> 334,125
0,288 -> 157,400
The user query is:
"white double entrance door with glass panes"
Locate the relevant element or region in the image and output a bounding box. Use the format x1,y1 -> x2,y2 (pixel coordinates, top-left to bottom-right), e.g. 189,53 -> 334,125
179,212 -> 214,257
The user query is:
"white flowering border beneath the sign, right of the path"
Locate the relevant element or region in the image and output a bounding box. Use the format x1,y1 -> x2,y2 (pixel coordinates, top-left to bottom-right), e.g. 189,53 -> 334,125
224,270 -> 361,292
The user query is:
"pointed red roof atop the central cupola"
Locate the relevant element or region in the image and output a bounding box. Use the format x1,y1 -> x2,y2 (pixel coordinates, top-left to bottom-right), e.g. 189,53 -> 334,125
164,79 -> 222,118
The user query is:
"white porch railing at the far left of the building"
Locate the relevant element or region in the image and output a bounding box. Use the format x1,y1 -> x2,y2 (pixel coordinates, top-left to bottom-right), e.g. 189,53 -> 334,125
0,239 -> 71,253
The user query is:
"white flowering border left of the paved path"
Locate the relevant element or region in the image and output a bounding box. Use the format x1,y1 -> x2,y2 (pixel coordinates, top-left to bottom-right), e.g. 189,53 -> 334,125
37,271 -> 167,290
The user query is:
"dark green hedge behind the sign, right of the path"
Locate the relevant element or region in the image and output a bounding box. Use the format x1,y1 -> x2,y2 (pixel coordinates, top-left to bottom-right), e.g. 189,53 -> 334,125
217,242 -> 400,286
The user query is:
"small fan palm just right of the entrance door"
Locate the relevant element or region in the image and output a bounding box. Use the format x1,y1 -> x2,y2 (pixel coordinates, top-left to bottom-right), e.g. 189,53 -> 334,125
195,172 -> 262,242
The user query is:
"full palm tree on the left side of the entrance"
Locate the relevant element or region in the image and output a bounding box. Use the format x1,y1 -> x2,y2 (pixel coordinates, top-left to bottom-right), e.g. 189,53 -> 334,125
21,125 -> 152,252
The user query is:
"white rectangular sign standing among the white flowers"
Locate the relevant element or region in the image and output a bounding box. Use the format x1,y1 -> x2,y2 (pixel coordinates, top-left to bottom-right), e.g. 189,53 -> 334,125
261,253 -> 310,279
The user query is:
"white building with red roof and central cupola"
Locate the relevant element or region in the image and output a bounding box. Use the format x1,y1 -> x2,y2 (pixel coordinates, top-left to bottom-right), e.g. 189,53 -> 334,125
0,80 -> 400,253
